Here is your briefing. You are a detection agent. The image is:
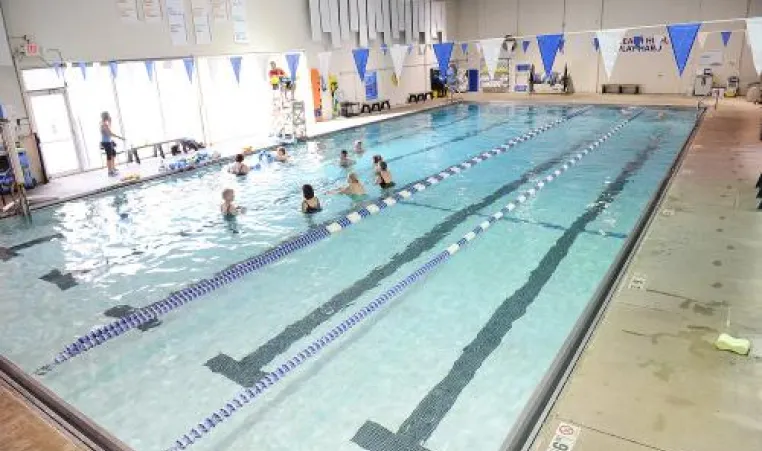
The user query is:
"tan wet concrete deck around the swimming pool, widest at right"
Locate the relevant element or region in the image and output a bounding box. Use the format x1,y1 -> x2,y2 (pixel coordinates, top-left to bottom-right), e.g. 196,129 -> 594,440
0,95 -> 762,451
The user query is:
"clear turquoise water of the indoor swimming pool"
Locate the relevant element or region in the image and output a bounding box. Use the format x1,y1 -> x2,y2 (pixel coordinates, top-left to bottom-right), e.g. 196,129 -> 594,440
0,103 -> 696,451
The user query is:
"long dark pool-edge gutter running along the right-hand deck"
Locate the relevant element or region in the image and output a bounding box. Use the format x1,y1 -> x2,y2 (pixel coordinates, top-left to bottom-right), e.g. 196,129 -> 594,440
500,107 -> 706,451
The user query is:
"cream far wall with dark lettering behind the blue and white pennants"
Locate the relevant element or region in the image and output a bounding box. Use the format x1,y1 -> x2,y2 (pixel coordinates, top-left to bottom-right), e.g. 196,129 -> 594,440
456,0 -> 762,93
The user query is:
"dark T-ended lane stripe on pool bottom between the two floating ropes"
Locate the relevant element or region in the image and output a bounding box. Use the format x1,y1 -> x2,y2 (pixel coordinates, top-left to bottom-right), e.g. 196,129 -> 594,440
204,124 -> 610,387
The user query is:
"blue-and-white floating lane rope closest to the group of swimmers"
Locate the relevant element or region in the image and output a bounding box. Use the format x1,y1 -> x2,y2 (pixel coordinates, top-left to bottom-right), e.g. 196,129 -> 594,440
35,106 -> 592,375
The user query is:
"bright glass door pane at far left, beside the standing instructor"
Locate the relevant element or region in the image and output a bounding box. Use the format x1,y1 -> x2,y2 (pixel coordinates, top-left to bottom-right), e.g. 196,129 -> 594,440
29,90 -> 82,177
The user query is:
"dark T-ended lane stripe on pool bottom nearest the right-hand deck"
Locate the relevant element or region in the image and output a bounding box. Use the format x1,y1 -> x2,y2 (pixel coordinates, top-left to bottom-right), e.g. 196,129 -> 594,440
352,128 -> 664,451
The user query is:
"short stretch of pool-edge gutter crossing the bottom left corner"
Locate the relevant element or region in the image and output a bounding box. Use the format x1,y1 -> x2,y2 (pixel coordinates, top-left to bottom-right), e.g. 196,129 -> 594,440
0,355 -> 132,451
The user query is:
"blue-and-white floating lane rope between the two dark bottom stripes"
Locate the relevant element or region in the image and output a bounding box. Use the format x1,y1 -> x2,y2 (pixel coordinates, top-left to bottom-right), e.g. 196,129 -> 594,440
167,109 -> 644,451
